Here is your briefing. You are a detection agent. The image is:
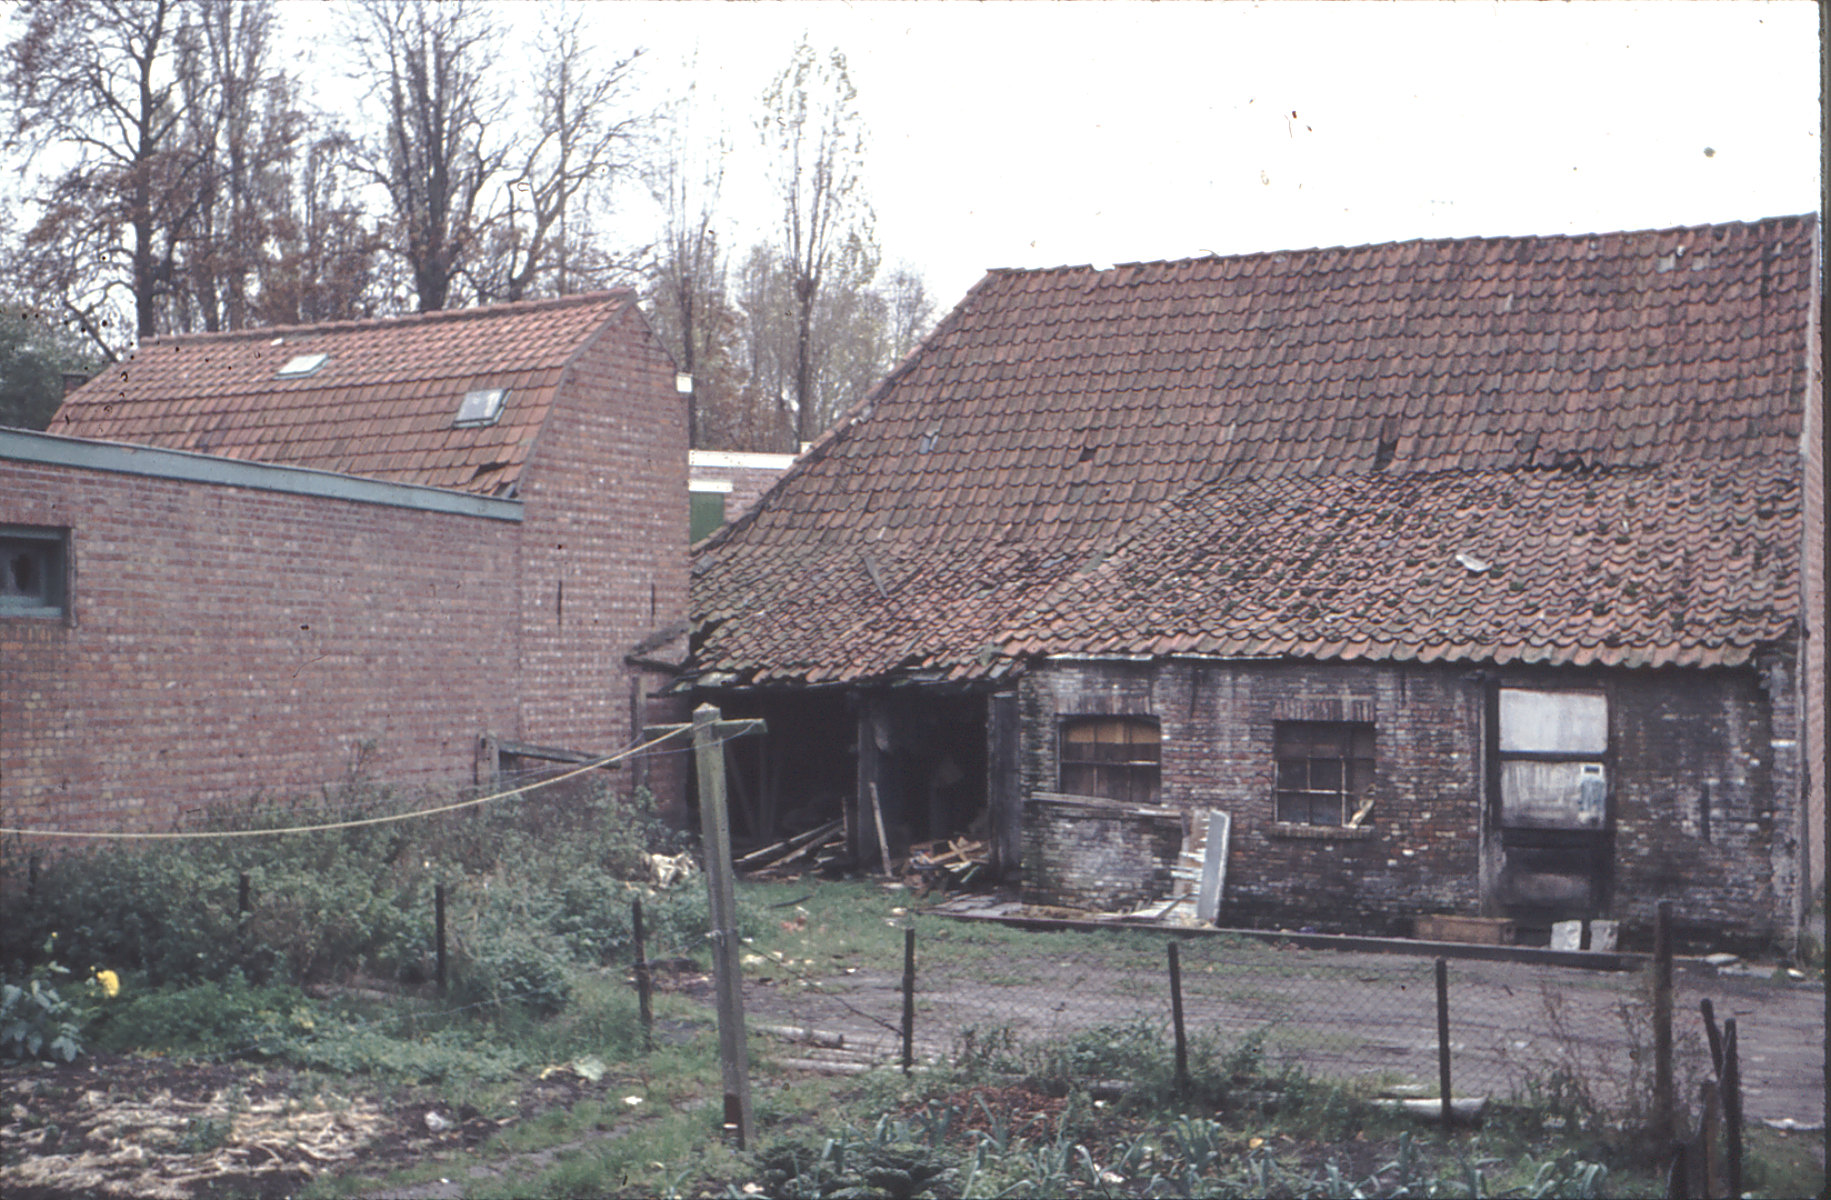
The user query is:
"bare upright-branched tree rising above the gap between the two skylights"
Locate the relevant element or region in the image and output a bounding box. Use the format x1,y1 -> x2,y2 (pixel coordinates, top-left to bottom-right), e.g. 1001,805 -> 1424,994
350,0 -> 507,311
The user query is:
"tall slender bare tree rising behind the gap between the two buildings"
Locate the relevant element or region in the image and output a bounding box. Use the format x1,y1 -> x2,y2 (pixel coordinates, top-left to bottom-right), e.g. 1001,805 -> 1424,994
758,40 -> 875,442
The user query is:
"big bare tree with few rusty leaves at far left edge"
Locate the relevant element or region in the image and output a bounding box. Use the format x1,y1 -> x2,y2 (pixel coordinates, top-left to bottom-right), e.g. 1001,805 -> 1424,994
0,0 -> 203,348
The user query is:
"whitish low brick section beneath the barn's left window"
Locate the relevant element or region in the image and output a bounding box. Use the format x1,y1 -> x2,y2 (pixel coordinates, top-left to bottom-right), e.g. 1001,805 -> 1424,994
1024,791 -> 1183,912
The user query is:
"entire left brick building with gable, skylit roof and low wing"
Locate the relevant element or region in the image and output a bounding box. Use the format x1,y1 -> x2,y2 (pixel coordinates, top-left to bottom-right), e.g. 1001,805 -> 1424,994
0,291 -> 687,830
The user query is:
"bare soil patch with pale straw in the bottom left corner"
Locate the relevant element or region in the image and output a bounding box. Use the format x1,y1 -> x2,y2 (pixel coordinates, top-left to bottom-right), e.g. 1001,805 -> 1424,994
0,1055 -> 637,1200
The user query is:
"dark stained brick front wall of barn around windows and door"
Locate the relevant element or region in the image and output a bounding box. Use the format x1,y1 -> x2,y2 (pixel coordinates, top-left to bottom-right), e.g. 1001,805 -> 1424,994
1020,661 -> 1798,942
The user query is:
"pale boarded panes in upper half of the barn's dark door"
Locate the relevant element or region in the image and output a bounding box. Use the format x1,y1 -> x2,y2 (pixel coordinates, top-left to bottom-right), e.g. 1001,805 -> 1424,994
1500,687 -> 1608,828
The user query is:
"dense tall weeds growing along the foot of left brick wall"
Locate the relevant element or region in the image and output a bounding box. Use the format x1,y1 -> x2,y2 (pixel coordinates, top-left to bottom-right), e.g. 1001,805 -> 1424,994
0,784 -> 707,1066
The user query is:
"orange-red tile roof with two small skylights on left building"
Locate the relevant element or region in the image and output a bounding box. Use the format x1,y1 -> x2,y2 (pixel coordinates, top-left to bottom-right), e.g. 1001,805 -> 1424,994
51,291 -> 635,495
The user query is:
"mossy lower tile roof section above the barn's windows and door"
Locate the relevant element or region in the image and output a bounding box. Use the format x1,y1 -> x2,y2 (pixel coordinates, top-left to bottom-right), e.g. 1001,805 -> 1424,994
1000,458 -> 1800,667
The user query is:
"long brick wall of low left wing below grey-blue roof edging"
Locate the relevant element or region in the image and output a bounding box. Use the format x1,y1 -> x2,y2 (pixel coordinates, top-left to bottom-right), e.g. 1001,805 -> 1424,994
0,460 -> 518,830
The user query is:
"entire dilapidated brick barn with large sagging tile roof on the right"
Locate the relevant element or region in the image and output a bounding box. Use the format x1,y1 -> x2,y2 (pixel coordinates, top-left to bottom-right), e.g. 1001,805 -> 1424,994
690,216 -> 1824,944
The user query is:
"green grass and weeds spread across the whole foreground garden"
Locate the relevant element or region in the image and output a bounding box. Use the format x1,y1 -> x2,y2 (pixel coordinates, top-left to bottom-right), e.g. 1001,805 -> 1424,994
4,839 -> 1822,1200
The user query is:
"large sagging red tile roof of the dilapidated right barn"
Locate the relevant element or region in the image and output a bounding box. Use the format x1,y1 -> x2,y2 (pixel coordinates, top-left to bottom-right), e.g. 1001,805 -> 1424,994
694,216 -> 1816,683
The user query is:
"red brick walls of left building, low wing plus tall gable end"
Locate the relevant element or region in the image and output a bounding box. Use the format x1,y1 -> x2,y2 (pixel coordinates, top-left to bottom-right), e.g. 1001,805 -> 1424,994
0,306 -> 687,830
